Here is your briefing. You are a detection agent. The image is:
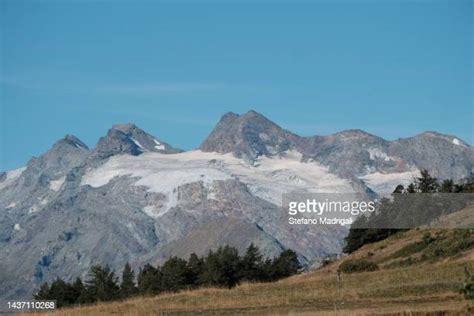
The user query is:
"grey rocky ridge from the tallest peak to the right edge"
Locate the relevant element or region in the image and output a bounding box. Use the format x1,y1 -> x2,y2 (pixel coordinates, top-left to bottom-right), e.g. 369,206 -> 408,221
200,111 -> 474,180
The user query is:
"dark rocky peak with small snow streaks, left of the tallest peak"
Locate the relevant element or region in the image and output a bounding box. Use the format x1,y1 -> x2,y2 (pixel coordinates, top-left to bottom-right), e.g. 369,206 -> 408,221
93,124 -> 181,159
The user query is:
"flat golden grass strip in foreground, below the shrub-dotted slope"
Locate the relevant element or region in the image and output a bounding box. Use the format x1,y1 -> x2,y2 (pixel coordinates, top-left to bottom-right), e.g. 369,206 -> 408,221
30,262 -> 474,315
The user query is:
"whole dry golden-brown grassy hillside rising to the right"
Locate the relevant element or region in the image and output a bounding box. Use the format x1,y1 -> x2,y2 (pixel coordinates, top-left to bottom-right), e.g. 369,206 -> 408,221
30,230 -> 474,315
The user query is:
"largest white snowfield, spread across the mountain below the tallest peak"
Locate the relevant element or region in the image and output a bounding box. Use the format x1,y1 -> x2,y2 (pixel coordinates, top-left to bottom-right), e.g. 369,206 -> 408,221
82,150 -> 354,210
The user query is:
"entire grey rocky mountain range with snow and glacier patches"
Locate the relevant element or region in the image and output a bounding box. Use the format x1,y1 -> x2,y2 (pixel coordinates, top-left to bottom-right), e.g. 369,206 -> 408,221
0,111 -> 474,299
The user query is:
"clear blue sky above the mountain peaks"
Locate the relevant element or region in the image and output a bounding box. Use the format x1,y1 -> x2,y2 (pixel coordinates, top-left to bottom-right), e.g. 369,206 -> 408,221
0,0 -> 474,170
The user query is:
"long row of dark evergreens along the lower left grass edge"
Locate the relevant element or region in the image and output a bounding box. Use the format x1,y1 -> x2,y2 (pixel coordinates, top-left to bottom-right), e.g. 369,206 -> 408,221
34,244 -> 301,307
